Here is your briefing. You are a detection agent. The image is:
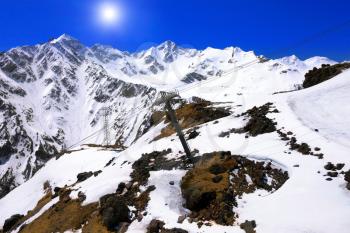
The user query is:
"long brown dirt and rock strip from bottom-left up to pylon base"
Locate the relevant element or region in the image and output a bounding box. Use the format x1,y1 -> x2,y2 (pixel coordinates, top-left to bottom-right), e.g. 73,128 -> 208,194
10,149 -> 185,233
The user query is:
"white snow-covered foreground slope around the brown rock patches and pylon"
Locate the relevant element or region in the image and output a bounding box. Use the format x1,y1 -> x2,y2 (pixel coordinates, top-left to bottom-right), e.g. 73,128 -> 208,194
0,71 -> 350,233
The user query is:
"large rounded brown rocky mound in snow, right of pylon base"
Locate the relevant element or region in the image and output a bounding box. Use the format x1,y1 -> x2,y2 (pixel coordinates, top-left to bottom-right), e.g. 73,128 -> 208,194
181,152 -> 288,225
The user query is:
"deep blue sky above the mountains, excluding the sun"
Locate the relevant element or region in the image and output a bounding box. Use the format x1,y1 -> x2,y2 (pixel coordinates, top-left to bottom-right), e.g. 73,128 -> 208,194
0,0 -> 350,60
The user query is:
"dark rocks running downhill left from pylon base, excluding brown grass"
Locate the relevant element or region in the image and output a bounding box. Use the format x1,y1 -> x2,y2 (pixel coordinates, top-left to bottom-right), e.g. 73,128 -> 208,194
100,149 -> 185,230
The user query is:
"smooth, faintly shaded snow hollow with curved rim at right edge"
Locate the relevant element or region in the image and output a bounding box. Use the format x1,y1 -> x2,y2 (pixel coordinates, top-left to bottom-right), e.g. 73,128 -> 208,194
289,71 -> 350,147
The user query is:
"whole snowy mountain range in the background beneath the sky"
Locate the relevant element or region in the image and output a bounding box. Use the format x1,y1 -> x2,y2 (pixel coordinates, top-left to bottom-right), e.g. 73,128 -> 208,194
0,34 -> 335,197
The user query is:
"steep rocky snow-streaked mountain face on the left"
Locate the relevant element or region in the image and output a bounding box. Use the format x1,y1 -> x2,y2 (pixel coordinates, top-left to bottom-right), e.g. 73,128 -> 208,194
0,35 -> 157,198
